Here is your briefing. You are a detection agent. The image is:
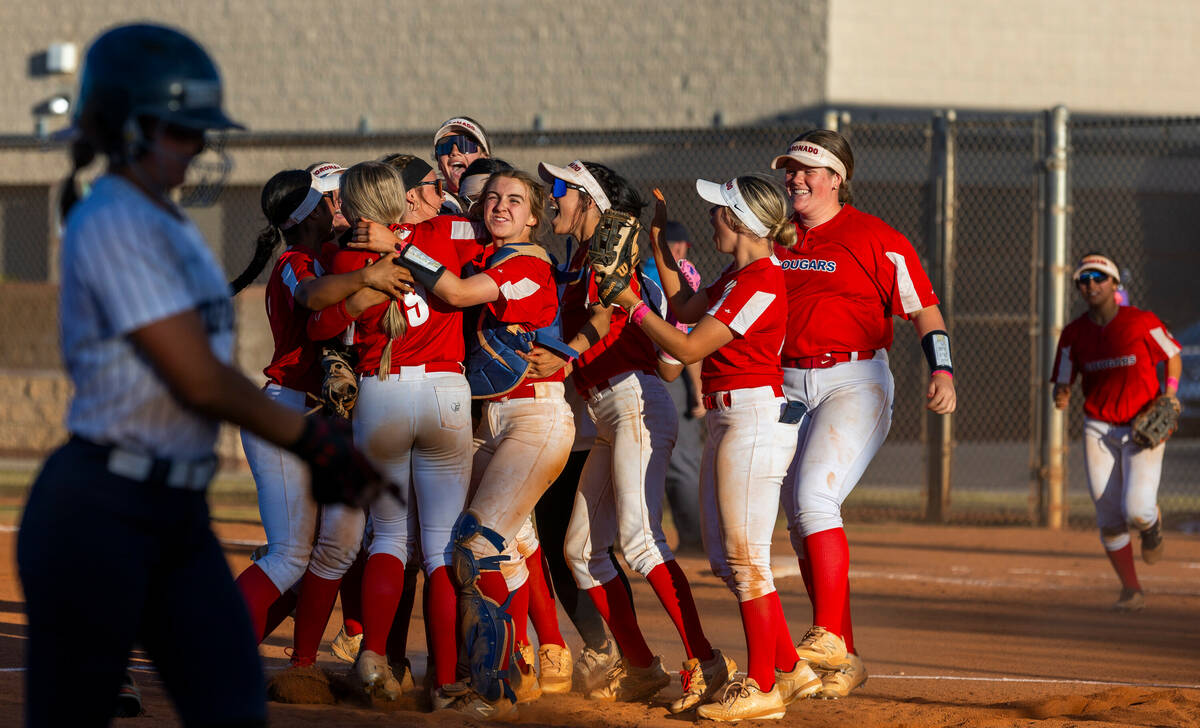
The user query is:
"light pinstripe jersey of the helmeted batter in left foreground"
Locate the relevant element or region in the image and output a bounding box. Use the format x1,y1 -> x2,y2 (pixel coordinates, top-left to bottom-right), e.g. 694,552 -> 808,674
59,175 -> 233,458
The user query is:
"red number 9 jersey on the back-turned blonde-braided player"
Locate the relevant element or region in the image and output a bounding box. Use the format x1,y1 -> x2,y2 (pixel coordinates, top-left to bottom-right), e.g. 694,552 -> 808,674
308,215 -> 486,375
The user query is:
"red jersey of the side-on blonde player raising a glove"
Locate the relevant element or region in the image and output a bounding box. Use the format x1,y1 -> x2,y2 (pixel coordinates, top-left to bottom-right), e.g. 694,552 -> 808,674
700,258 -> 788,395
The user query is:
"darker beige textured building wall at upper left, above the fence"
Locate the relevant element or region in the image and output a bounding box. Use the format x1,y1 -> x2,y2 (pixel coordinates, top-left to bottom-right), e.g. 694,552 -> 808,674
0,0 -> 826,134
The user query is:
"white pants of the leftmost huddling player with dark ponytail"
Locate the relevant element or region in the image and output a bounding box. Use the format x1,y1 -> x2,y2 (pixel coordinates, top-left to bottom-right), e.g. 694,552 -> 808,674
241,384 -> 366,592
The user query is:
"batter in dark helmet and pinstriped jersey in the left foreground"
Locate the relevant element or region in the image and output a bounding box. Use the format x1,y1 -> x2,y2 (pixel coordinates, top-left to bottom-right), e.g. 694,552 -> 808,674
17,25 -> 382,726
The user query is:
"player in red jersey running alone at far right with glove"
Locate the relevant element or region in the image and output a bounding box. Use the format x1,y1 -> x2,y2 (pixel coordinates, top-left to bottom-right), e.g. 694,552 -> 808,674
1052,253 -> 1183,612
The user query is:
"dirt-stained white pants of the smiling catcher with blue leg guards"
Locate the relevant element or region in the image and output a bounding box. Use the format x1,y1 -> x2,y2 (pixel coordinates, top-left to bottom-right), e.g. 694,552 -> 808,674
467,381 -> 575,584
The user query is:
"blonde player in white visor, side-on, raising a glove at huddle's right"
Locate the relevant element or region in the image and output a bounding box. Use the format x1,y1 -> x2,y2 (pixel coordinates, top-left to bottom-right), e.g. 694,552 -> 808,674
617,176 -> 820,722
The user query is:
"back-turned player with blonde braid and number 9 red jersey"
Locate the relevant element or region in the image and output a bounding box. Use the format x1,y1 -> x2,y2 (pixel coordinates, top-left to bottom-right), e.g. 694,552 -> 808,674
308,162 -> 479,699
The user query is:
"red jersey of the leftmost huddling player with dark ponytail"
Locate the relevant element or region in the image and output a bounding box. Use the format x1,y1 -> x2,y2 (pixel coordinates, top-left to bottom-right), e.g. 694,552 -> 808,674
263,247 -> 323,395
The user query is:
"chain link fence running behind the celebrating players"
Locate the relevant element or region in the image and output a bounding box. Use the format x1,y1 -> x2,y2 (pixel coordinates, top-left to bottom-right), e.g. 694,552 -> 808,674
0,114 -> 1200,525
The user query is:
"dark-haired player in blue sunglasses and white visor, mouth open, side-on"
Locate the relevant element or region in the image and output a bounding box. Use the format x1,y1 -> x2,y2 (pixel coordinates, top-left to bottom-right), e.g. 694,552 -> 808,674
539,161 -> 736,712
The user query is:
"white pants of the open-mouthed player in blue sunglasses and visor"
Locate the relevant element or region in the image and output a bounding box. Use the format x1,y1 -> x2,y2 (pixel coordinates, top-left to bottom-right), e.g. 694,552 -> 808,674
563,372 -> 679,589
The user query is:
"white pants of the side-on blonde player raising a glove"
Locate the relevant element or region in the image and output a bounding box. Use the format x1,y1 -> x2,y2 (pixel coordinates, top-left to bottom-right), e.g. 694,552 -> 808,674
700,386 -> 799,602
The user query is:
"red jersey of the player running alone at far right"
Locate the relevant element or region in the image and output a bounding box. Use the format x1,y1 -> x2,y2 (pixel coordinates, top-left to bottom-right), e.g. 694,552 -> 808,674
1052,306 -> 1180,425
